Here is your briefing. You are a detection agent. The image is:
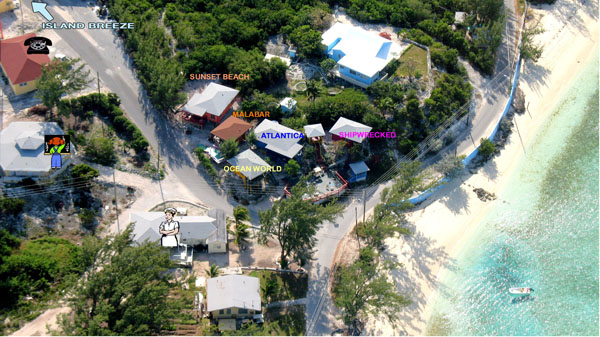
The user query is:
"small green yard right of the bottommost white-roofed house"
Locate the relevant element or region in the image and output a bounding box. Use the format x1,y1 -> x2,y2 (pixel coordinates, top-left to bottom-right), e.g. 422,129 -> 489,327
250,270 -> 308,303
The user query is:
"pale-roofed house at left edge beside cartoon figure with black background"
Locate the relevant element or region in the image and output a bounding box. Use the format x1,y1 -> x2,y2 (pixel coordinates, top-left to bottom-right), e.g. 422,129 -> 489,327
0,122 -> 75,177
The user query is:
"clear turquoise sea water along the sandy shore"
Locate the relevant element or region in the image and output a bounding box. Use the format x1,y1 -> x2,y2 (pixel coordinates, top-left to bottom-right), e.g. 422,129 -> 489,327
427,53 -> 599,336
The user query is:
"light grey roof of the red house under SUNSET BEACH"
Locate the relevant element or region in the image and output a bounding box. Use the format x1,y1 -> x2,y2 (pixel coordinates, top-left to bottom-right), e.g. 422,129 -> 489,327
183,82 -> 239,117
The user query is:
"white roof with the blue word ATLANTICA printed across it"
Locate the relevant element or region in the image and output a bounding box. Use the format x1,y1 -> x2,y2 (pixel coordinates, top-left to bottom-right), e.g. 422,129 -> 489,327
254,118 -> 302,158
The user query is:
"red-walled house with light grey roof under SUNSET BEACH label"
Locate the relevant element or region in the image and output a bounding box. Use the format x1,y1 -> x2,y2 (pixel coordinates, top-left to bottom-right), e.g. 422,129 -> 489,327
182,82 -> 239,125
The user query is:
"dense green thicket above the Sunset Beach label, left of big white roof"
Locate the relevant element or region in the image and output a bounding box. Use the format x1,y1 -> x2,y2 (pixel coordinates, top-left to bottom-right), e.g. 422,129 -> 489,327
108,0 -> 318,110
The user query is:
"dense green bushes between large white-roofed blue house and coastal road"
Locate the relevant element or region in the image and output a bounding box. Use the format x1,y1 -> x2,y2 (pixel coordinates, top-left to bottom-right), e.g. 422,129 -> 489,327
342,0 -> 504,74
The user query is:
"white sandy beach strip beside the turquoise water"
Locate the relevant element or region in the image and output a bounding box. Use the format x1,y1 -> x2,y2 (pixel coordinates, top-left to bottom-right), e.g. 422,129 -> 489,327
366,0 -> 598,336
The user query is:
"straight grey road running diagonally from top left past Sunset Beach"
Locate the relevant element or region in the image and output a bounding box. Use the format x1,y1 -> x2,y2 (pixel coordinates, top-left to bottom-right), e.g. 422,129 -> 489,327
22,0 -> 235,213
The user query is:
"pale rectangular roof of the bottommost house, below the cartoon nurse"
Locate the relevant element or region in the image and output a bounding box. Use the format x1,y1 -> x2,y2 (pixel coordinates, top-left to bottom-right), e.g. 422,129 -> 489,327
206,275 -> 261,311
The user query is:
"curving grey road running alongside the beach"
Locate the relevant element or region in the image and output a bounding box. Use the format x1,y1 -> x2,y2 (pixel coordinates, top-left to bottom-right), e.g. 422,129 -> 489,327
306,0 -> 517,336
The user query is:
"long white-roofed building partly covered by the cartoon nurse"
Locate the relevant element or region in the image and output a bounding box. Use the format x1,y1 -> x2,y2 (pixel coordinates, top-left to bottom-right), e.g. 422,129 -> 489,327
129,208 -> 227,253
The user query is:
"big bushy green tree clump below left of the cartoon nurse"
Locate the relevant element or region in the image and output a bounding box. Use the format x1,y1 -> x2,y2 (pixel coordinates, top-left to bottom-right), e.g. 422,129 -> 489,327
60,226 -> 177,336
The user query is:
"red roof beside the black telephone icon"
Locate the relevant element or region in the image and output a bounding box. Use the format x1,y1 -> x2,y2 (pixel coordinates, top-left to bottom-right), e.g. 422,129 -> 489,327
0,33 -> 50,85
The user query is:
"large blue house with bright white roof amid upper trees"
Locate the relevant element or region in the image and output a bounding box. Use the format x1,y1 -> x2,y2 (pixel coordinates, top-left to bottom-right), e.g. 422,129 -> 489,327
321,22 -> 402,88
